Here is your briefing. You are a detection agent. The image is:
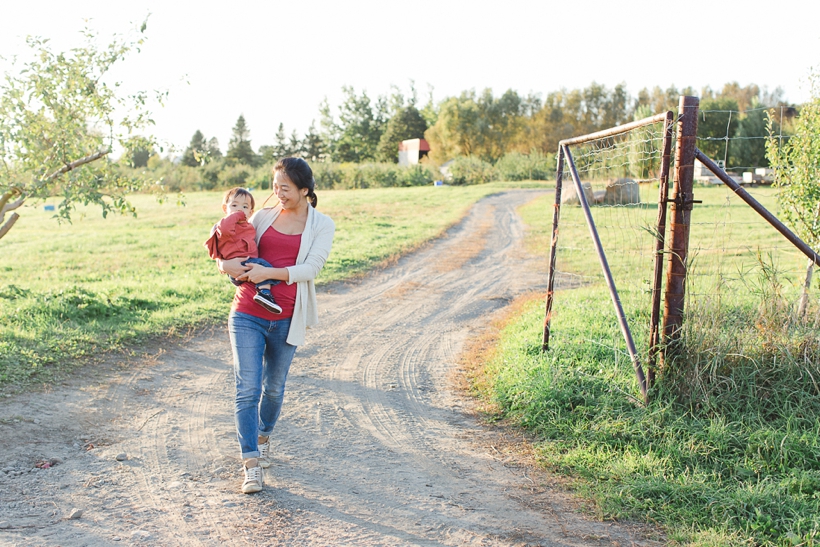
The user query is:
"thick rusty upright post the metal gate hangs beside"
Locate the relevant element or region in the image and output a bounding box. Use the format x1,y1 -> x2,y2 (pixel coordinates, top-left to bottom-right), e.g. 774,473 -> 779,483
662,97 -> 700,361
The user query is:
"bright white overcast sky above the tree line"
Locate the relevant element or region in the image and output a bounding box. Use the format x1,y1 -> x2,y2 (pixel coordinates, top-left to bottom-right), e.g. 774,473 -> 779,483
0,0 -> 820,155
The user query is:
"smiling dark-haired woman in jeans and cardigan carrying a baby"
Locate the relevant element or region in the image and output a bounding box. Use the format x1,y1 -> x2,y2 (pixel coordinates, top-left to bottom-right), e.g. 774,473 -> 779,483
219,158 -> 336,494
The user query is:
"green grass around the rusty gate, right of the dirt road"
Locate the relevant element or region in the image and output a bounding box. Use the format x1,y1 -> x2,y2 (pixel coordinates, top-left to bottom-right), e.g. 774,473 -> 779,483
479,188 -> 820,545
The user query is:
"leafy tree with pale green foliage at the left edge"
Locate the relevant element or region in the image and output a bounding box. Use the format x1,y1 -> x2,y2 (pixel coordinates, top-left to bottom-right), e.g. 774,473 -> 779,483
0,23 -> 162,242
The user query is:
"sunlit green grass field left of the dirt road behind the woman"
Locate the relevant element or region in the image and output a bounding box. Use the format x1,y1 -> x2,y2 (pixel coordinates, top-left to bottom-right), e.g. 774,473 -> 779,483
0,184 -> 544,389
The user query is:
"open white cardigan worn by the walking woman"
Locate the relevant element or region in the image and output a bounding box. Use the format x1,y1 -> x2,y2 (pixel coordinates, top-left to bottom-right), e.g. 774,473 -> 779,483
251,206 -> 336,346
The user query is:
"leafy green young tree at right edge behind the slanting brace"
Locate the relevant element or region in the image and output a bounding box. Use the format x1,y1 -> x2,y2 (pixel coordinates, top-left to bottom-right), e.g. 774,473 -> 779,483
766,78 -> 820,315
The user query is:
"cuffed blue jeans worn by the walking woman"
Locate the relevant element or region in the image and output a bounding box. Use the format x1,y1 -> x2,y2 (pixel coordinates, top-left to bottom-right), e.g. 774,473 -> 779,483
228,312 -> 296,459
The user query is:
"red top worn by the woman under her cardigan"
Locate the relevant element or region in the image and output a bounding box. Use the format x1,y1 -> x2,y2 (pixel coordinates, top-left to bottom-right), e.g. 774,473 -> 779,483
231,226 -> 302,321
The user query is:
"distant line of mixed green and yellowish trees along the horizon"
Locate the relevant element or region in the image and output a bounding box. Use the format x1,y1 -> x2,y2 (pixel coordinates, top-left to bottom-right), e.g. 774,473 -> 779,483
125,82 -> 796,193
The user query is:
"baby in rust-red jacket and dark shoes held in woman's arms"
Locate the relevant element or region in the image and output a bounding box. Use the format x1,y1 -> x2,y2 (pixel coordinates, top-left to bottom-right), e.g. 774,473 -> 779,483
205,188 -> 282,313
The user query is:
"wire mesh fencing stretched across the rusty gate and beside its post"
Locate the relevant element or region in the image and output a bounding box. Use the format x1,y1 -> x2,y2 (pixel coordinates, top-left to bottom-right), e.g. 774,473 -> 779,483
545,99 -> 807,398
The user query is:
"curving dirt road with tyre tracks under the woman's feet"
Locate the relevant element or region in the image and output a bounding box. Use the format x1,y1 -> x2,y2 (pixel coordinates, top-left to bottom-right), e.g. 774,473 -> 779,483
0,191 -> 657,547
